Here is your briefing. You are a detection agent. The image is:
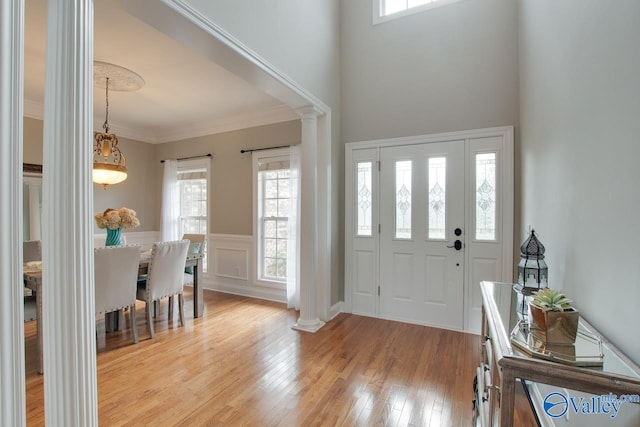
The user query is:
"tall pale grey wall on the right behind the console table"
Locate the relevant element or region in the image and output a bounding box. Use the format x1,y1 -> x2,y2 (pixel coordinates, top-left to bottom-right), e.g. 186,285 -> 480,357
520,0 -> 640,363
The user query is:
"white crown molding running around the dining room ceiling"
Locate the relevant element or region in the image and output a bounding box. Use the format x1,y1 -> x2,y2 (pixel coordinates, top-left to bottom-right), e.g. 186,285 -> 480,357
24,99 -> 300,144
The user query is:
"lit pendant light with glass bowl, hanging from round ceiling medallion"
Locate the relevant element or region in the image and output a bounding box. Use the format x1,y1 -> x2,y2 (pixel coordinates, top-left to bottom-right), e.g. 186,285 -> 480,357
93,61 -> 144,190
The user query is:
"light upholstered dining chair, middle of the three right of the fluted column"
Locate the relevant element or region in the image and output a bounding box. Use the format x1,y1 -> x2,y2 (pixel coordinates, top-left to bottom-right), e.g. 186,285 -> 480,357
137,240 -> 189,338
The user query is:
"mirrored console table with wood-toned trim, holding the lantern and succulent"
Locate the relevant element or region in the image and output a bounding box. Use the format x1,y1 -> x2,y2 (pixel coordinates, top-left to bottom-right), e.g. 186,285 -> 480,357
476,282 -> 640,427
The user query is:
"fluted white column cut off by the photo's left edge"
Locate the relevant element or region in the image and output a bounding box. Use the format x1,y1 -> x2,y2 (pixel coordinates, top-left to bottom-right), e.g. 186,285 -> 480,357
0,0 -> 26,426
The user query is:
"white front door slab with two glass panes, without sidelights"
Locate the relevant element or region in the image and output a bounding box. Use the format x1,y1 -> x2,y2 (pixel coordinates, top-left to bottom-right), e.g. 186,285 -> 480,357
379,140 -> 465,329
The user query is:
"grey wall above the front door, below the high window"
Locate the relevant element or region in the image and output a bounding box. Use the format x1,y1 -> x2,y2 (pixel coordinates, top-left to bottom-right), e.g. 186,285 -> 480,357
341,0 -> 518,142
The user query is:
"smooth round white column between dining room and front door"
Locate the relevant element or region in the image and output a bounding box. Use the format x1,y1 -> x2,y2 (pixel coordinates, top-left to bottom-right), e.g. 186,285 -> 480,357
293,107 -> 324,332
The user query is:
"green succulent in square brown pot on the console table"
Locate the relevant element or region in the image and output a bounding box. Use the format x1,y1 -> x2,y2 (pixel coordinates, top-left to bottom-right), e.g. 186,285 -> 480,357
529,288 -> 580,345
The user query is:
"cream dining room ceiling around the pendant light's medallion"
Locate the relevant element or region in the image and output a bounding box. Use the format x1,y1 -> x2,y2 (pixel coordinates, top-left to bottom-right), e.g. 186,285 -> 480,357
24,0 -> 298,143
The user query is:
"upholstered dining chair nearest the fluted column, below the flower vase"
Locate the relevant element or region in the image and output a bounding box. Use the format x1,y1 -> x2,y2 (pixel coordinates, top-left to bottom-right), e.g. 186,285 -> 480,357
93,245 -> 140,344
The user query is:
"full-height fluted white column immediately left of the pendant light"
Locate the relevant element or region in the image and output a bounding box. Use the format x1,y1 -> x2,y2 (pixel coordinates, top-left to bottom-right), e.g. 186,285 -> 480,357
41,0 -> 98,426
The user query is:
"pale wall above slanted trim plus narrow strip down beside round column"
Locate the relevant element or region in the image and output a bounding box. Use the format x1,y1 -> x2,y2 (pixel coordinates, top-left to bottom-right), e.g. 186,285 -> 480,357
184,0 -> 344,304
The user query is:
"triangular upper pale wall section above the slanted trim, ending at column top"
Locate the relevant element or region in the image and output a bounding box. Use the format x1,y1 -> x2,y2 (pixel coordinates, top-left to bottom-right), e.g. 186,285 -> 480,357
185,0 -> 340,112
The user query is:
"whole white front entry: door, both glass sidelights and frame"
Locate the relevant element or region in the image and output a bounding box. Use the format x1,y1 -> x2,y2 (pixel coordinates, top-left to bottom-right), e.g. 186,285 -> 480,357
345,127 -> 513,333
